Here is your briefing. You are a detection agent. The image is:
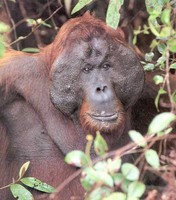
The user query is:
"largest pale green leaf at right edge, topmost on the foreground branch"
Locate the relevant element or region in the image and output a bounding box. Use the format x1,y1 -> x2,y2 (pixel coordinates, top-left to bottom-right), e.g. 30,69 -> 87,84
148,112 -> 176,134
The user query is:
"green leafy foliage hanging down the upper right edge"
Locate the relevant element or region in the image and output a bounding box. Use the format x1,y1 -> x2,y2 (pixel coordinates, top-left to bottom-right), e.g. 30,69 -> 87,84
133,0 -> 176,112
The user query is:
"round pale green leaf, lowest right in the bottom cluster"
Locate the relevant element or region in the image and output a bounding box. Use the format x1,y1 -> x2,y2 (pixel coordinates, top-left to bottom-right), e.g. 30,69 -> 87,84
128,181 -> 145,198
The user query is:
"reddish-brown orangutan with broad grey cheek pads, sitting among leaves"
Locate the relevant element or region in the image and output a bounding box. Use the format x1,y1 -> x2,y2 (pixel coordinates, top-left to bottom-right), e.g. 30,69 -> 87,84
0,13 -> 144,200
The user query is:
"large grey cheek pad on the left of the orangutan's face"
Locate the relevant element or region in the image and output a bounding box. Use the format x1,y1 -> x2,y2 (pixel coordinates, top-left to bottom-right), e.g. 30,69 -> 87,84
50,41 -> 88,115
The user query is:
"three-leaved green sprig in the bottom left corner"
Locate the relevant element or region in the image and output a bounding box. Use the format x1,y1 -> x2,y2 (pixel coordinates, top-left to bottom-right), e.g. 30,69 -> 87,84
0,161 -> 55,200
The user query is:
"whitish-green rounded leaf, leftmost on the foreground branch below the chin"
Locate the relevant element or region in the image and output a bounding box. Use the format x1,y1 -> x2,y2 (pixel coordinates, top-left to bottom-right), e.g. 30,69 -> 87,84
65,150 -> 89,167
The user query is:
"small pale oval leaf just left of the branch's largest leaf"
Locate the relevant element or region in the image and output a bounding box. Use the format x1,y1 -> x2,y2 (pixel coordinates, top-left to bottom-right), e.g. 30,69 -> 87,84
128,130 -> 147,147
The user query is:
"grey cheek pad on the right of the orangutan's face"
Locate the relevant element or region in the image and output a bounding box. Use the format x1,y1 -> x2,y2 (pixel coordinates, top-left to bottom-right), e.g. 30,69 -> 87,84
111,49 -> 144,108
